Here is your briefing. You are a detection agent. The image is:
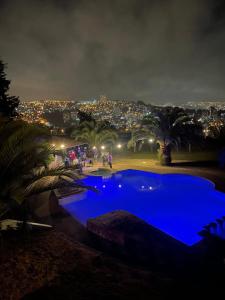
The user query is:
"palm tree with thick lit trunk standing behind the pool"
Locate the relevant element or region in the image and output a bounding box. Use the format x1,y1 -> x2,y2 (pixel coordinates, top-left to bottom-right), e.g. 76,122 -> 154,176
142,107 -> 190,165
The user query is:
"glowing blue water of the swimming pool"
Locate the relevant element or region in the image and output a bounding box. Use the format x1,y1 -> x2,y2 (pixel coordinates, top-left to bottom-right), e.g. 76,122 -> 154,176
61,170 -> 225,246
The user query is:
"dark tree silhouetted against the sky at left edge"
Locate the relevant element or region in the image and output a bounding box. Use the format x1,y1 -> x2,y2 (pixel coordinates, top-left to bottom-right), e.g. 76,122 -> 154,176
0,60 -> 19,118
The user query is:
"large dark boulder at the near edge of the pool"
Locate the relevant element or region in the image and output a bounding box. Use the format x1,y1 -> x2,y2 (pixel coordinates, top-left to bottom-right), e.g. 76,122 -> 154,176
87,210 -> 187,264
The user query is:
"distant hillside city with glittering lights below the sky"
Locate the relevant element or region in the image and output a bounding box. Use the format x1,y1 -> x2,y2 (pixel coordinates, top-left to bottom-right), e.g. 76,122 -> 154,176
19,96 -> 225,134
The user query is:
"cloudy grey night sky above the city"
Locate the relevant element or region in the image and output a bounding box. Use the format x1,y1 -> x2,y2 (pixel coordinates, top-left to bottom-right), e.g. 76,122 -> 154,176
0,0 -> 225,104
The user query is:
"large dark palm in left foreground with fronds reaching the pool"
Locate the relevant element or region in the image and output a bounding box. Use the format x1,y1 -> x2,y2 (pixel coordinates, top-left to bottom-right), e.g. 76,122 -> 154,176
0,120 -> 81,217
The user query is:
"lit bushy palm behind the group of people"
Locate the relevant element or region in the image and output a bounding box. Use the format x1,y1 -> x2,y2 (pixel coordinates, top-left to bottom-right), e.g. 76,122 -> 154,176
71,121 -> 118,148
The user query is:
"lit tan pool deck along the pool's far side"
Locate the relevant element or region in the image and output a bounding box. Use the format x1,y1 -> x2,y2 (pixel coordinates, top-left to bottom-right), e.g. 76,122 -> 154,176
84,158 -> 225,192
